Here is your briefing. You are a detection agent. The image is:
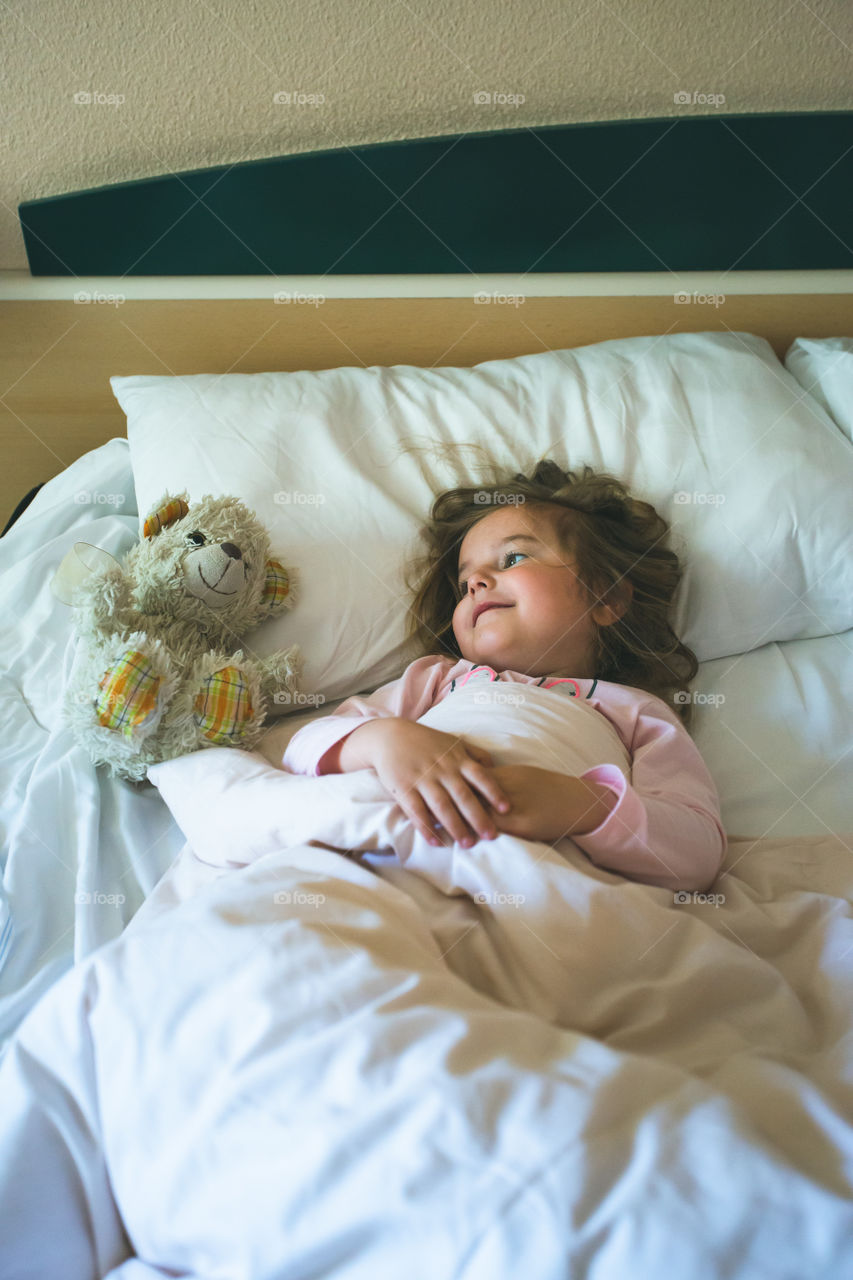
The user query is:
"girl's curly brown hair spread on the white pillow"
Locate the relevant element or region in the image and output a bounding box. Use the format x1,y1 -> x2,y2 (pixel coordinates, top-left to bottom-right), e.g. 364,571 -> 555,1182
407,458 -> 699,724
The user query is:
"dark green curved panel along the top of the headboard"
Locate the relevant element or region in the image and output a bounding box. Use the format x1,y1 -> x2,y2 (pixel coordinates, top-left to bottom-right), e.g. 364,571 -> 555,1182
19,113 -> 853,275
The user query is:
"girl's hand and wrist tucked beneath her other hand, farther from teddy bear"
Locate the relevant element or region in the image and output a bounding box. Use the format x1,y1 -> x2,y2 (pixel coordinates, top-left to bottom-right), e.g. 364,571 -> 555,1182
492,764 -> 616,845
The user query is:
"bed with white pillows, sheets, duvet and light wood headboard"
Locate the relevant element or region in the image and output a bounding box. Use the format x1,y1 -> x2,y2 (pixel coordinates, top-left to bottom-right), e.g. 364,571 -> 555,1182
0,115 -> 853,1280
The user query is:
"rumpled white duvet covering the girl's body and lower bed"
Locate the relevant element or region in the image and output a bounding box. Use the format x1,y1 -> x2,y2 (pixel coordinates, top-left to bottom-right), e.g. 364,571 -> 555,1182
0,695 -> 853,1280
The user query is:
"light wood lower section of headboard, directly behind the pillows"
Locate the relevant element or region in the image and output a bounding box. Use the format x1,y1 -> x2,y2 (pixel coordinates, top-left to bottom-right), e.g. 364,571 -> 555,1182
0,292 -> 853,529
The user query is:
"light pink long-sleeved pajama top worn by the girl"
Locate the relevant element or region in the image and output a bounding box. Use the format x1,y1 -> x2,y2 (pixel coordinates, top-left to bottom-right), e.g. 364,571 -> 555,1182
282,655 -> 726,891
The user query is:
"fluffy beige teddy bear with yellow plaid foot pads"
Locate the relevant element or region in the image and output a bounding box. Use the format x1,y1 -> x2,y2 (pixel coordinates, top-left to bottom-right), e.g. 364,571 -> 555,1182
58,493 -> 301,781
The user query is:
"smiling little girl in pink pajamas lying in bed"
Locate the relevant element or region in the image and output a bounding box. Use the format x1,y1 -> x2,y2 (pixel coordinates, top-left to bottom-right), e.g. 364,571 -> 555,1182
283,461 -> 726,890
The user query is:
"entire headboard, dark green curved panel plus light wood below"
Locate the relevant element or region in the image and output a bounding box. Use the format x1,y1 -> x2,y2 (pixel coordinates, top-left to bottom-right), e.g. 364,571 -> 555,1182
0,113 -> 853,527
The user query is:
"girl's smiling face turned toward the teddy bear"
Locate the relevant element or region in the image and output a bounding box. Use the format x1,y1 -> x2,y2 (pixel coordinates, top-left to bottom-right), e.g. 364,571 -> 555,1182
453,504 -> 619,678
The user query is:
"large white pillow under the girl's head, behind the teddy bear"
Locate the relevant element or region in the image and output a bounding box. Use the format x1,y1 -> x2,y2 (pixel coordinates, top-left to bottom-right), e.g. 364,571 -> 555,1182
111,333 -> 853,712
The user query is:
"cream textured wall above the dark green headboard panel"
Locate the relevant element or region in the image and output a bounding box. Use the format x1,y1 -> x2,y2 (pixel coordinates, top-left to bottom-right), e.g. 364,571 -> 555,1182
0,0 -> 853,269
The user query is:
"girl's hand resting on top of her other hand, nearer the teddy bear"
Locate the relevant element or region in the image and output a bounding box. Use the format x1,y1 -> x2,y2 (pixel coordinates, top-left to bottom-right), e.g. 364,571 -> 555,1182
341,717 -> 507,845
